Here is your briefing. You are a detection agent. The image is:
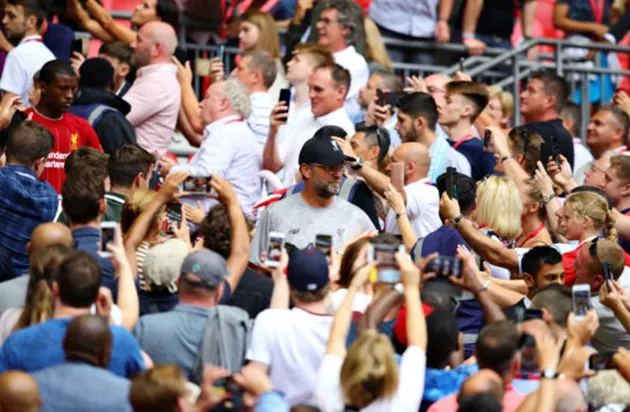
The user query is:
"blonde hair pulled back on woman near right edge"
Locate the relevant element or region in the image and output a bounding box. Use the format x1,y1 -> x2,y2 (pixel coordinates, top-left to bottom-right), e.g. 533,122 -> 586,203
565,191 -> 617,242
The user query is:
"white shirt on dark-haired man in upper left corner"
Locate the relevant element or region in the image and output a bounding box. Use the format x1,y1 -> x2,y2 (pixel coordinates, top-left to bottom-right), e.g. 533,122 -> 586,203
0,35 -> 55,107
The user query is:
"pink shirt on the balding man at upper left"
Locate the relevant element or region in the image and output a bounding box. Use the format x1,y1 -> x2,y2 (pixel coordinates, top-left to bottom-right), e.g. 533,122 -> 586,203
124,63 -> 181,157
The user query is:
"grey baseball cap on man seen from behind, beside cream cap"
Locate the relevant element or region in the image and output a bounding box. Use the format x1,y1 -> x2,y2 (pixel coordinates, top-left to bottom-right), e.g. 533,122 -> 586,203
180,249 -> 230,289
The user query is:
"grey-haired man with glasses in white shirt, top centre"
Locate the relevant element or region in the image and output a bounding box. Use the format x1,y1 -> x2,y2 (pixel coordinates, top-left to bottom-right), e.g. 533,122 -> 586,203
316,0 -> 370,113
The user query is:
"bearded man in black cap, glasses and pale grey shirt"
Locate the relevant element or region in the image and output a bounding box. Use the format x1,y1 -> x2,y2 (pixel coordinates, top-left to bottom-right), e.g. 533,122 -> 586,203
250,135 -> 375,264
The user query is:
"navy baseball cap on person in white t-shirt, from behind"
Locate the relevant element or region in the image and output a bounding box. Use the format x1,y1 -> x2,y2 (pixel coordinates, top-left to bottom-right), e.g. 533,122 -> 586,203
287,248 -> 329,292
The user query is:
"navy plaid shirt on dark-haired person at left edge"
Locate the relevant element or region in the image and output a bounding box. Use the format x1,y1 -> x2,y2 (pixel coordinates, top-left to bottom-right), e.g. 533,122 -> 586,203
0,165 -> 59,274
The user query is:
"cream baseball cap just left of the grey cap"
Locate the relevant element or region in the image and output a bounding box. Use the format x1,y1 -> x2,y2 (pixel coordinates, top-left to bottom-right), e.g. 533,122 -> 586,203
142,239 -> 188,286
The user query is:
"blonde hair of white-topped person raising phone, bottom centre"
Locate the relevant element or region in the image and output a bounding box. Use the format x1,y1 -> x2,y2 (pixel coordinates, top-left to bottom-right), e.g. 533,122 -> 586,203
340,330 -> 398,408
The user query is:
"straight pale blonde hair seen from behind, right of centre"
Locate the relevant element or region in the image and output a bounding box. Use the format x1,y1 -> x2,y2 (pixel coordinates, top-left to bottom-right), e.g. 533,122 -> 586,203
477,176 -> 523,239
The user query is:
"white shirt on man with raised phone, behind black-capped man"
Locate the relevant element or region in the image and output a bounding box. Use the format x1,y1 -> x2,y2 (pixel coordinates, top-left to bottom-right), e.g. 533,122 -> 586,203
278,104 -> 354,186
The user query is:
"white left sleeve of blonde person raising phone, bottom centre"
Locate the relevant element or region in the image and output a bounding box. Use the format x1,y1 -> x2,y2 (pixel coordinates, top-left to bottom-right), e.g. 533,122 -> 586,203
315,354 -> 344,412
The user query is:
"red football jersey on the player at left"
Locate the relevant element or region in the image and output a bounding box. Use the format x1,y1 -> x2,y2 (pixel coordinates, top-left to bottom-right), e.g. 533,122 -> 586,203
26,108 -> 103,193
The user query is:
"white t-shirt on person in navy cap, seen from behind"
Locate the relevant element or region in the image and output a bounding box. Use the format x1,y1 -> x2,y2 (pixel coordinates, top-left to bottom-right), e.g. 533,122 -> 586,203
247,308 -> 333,405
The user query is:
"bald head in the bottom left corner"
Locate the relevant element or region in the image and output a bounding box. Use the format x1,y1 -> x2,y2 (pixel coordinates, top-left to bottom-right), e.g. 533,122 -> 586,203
0,371 -> 41,412
